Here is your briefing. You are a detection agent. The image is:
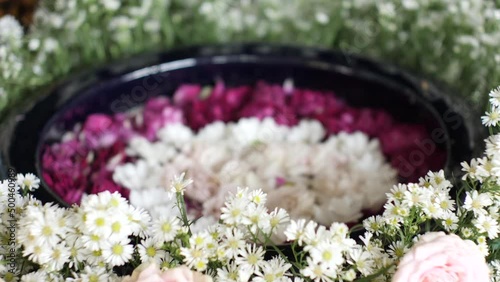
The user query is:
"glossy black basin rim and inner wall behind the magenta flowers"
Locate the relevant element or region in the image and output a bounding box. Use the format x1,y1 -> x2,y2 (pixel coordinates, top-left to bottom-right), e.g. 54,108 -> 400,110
0,44 -> 479,205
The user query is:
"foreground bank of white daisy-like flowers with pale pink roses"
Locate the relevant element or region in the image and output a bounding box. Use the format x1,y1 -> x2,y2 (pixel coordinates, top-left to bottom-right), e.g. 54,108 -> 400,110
0,82 -> 500,282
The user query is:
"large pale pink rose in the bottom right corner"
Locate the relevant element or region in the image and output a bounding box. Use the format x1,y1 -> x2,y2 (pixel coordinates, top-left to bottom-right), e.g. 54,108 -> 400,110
392,232 -> 490,282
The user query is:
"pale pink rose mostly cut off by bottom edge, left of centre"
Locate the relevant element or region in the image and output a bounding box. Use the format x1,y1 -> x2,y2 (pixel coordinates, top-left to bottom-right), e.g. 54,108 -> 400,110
122,264 -> 212,282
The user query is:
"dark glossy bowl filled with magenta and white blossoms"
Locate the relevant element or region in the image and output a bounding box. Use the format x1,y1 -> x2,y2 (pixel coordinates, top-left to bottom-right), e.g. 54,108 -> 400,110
3,45 -> 469,229
